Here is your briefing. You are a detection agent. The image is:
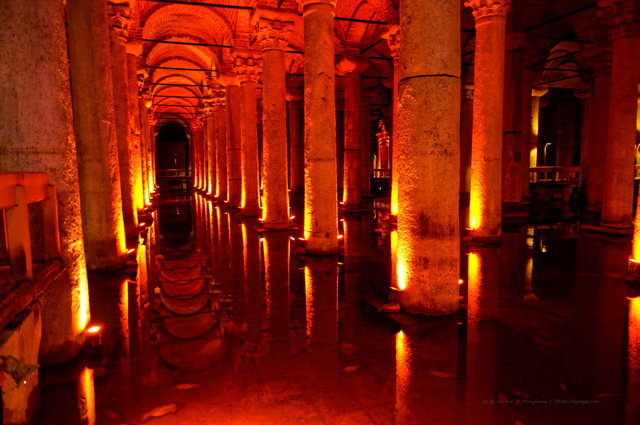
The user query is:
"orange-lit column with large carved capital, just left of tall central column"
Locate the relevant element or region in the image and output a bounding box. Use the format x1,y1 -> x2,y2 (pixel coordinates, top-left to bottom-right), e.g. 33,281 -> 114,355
252,8 -> 297,229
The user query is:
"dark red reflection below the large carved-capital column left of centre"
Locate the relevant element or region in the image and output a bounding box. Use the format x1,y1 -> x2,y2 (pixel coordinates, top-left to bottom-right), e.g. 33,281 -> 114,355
263,232 -> 290,366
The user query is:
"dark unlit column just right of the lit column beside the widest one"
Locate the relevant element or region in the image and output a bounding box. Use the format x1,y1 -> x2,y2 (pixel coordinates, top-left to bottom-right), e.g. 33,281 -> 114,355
502,33 -> 526,206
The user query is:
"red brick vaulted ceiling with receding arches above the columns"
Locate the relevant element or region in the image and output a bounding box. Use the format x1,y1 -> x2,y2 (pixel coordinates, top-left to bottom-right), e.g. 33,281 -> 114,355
127,0 -> 606,121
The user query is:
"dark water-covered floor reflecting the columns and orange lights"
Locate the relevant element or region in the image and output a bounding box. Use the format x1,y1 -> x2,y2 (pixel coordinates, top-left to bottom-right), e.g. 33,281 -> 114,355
40,196 -> 640,425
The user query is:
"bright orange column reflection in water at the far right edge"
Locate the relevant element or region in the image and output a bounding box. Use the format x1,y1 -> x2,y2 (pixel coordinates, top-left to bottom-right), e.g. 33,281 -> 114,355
626,297 -> 640,425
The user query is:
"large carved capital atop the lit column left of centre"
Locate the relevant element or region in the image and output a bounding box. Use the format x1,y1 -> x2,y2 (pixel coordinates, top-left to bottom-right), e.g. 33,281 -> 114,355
251,5 -> 297,50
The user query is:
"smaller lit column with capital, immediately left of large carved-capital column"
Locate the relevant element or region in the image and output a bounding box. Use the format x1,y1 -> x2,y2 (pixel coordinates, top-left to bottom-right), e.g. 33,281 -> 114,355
234,51 -> 264,216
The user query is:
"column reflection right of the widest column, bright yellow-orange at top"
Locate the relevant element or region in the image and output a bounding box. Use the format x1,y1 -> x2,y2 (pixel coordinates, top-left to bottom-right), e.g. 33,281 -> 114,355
466,247 -> 500,425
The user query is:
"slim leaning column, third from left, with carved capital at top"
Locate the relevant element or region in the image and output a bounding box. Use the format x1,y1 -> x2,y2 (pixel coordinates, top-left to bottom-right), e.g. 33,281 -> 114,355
109,1 -> 138,238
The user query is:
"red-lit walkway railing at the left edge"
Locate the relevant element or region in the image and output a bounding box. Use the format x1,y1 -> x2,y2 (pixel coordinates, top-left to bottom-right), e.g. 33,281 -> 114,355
0,173 -> 60,281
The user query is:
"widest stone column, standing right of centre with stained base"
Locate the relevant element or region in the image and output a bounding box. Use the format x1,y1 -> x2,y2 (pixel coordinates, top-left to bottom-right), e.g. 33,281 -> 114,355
396,0 -> 460,315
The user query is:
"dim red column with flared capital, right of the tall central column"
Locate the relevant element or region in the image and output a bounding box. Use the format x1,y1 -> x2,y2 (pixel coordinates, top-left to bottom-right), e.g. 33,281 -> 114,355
336,56 -> 369,210
